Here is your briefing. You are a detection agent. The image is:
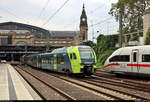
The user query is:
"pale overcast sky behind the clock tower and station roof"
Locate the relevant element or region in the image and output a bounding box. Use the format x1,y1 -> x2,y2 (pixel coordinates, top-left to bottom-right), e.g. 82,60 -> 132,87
0,0 -> 118,40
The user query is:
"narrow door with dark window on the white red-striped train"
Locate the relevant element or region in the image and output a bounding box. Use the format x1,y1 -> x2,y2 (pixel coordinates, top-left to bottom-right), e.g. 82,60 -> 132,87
131,49 -> 139,73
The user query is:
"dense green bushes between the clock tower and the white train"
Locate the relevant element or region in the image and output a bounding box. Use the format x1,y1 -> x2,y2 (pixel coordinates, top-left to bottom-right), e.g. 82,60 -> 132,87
86,34 -> 118,68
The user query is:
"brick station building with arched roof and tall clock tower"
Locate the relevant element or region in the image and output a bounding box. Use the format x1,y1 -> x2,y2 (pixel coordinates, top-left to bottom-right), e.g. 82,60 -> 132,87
0,5 -> 88,47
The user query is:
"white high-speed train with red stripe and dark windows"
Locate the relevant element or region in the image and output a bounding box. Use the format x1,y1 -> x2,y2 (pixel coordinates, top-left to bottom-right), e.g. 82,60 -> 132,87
104,45 -> 150,76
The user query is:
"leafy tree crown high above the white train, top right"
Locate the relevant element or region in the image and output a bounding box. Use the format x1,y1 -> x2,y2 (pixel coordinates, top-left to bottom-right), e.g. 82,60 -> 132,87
109,0 -> 150,34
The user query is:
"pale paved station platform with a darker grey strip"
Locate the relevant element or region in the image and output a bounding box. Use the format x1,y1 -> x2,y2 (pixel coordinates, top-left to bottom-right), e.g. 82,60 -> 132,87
0,63 -> 42,100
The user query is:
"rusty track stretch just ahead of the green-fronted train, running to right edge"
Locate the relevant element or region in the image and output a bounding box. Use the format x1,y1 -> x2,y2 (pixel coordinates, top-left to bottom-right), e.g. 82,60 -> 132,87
81,76 -> 150,100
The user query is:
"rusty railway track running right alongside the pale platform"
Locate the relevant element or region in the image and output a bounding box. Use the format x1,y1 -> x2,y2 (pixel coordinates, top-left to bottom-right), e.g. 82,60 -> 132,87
15,66 -> 76,100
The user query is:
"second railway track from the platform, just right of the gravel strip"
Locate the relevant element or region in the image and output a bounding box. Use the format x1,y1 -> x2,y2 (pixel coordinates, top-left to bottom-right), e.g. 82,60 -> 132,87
15,65 -> 149,100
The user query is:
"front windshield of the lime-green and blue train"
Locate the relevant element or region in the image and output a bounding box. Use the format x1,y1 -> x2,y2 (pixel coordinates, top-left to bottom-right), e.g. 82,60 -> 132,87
79,48 -> 94,59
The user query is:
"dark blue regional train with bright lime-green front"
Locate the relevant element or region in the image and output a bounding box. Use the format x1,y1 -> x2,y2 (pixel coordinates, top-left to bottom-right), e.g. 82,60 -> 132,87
21,46 -> 97,76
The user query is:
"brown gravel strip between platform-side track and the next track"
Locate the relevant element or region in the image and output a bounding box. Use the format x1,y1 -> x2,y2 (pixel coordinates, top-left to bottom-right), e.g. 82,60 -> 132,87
18,67 -> 107,100
